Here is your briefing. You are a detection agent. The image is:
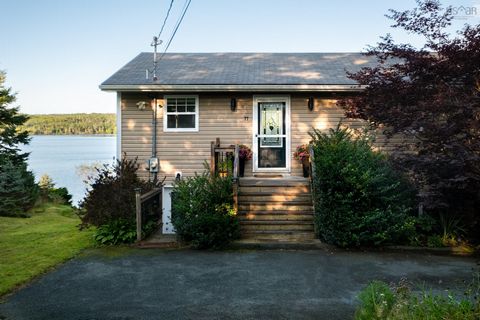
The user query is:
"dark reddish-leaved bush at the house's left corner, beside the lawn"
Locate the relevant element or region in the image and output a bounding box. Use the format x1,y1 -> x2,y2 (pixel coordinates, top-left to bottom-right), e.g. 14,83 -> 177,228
79,157 -> 156,244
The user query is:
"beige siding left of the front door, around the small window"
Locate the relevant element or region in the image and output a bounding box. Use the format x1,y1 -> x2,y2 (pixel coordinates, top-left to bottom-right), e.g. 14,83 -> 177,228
122,94 -> 252,183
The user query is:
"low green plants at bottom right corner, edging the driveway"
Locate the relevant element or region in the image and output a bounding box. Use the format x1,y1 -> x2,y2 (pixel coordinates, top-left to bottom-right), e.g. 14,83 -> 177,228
355,281 -> 480,320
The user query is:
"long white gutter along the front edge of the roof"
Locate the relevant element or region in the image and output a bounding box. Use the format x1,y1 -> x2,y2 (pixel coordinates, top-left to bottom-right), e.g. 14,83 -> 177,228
99,84 -> 365,92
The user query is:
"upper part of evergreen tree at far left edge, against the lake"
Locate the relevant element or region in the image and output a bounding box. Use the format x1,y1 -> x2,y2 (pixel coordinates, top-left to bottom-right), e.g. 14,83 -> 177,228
0,71 -> 29,162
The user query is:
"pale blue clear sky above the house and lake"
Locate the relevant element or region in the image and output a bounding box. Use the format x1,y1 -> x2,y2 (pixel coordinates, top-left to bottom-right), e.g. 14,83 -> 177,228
0,0 -> 480,114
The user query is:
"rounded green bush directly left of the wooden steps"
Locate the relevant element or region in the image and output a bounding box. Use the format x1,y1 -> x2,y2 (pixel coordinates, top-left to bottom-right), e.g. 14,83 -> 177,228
172,173 -> 239,249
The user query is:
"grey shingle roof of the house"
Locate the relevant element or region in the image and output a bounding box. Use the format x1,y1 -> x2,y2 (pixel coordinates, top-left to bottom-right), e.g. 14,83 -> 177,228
102,52 -> 375,86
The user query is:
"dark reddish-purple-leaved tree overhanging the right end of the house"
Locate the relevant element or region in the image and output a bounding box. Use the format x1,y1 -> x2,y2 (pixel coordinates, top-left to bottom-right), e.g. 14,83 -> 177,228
339,0 -> 480,238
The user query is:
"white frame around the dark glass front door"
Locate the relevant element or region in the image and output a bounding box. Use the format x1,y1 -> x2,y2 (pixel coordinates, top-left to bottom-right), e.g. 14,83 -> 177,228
252,94 -> 292,173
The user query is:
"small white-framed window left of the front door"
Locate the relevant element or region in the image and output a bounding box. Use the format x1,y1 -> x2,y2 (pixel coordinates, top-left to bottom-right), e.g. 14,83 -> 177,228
163,96 -> 198,132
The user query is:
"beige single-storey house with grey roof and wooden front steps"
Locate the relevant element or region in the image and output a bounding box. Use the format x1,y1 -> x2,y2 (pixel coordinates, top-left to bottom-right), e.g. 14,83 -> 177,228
100,53 -> 388,239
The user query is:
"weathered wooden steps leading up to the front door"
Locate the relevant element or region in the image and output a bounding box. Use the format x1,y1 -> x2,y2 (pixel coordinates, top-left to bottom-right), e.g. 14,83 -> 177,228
238,177 -> 315,242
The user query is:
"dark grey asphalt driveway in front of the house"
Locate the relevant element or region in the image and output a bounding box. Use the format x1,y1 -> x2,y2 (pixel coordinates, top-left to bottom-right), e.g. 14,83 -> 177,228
0,249 -> 478,320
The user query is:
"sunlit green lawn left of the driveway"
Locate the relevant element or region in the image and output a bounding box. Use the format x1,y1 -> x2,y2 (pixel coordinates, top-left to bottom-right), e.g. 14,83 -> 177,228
0,203 -> 94,296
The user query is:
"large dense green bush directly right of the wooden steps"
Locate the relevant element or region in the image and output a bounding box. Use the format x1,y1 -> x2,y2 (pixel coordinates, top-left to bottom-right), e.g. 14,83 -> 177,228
310,125 -> 415,247
